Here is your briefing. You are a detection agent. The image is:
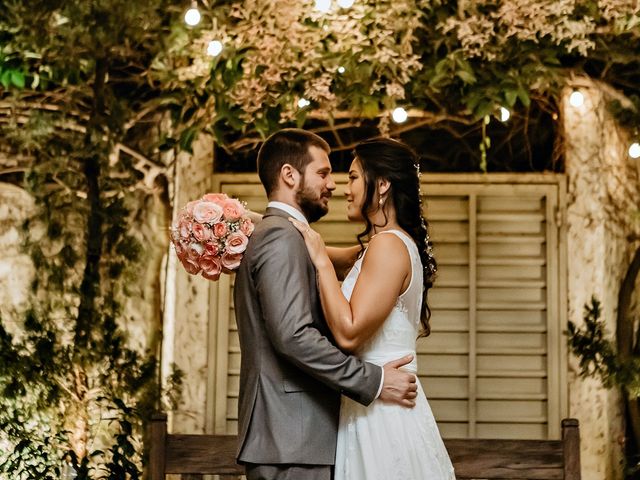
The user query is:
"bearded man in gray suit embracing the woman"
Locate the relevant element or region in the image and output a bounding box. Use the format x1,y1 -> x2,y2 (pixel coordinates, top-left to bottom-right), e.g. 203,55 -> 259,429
234,129 -> 417,480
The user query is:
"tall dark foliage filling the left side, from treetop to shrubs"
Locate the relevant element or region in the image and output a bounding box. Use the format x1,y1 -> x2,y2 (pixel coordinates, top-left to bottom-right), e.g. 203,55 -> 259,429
0,0 -> 179,479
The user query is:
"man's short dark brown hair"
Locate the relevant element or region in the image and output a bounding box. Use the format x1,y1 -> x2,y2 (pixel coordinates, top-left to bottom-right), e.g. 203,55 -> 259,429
258,128 -> 331,197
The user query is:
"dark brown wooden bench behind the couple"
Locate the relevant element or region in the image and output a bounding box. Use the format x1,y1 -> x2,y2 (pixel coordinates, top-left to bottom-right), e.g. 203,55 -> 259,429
149,414 -> 580,480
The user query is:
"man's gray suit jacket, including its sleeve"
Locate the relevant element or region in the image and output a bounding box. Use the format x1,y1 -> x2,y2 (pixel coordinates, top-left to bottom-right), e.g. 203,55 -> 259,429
234,208 -> 382,465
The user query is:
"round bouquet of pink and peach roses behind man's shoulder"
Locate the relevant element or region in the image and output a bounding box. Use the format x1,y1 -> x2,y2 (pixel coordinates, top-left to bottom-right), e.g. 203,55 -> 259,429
171,193 -> 254,281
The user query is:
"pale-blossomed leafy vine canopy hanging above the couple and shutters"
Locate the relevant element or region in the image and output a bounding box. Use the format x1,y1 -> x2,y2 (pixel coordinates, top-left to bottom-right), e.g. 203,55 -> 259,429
153,0 -> 640,152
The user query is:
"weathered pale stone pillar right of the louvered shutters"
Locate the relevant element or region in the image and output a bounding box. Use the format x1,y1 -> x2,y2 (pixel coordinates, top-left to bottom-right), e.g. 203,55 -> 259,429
562,83 -> 640,480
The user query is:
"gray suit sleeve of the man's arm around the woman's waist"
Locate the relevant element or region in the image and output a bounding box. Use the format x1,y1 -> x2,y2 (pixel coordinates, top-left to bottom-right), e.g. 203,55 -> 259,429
253,227 -> 382,405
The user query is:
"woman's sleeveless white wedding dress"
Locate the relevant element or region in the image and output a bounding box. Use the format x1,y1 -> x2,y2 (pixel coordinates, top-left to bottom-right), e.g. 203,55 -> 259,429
335,230 -> 455,480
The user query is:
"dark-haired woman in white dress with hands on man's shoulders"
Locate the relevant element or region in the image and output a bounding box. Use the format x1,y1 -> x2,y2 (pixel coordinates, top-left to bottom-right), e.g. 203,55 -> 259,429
290,139 -> 455,480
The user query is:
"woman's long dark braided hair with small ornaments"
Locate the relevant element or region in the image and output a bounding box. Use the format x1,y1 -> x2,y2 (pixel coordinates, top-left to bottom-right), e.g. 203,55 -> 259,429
354,138 -> 437,336
